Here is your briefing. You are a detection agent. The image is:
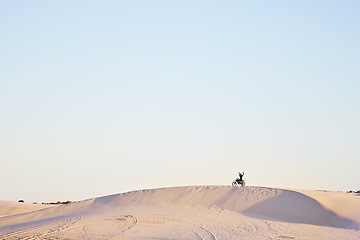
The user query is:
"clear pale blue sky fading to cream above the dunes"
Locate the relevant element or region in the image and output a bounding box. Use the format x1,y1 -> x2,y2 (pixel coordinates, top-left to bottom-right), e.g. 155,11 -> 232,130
0,0 -> 360,202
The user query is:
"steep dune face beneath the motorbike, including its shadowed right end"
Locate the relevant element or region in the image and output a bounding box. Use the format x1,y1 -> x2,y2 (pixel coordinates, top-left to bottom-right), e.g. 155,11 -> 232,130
90,186 -> 358,228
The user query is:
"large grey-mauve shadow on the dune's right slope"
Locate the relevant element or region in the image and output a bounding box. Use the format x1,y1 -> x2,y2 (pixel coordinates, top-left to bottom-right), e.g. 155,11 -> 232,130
242,190 -> 358,229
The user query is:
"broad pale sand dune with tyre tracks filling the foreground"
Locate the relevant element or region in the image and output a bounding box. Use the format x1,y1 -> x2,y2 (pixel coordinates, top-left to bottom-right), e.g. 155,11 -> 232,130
0,186 -> 360,239
